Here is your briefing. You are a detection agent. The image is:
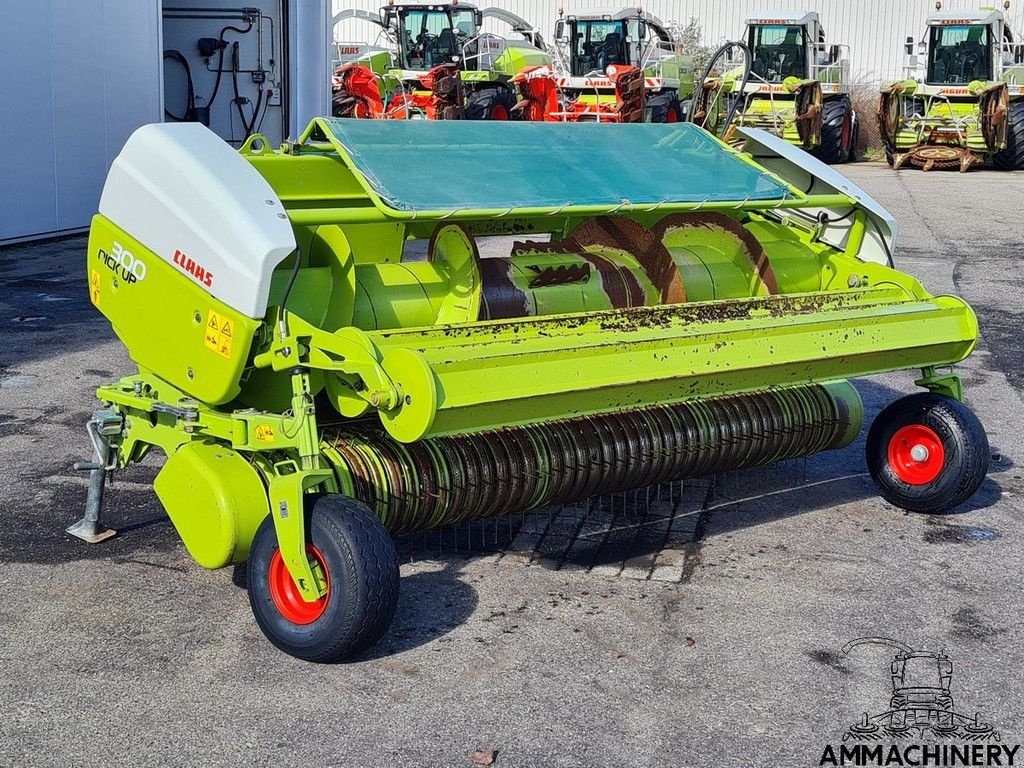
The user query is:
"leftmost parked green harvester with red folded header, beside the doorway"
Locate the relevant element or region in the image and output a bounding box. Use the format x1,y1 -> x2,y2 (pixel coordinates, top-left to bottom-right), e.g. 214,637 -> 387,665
333,0 -> 551,120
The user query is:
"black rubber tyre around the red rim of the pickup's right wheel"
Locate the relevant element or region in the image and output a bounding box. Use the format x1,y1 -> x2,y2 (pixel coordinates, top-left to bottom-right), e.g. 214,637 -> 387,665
865,392 -> 991,514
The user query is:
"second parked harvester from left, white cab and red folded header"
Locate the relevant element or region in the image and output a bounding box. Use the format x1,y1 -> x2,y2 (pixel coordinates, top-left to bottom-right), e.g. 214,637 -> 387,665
515,7 -> 693,123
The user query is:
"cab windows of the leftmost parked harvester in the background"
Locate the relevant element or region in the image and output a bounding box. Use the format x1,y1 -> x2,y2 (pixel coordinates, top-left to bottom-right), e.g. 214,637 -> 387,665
398,7 -> 476,70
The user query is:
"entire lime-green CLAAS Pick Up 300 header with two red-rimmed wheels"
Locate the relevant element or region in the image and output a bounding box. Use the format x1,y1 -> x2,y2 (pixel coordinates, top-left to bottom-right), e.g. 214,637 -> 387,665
72,119 -> 987,660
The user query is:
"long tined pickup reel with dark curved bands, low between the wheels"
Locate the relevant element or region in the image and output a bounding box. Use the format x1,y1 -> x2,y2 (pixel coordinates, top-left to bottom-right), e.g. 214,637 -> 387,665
322,382 -> 861,534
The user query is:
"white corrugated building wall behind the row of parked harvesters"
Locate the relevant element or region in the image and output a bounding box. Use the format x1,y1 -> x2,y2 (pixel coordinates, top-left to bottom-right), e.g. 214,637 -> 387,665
334,0 -> 1024,83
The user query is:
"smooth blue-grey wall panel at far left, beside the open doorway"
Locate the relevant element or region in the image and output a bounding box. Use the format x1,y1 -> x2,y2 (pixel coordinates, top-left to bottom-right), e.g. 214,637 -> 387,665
0,0 -> 163,243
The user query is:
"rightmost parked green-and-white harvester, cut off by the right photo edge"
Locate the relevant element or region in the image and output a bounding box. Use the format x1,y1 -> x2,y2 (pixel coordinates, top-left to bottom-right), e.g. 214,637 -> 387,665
878,2 -> 1024,172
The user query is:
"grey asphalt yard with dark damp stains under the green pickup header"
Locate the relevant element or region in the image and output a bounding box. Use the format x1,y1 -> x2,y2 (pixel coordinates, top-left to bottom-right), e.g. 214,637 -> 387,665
0,164 -> 1024,768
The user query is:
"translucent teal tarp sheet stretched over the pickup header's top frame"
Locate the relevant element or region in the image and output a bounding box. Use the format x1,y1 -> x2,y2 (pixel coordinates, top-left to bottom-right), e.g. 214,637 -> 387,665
325,118 -> 788,211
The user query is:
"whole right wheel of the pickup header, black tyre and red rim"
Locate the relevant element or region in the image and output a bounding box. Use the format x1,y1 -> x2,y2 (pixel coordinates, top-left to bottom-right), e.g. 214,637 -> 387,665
866,392 -> 990,514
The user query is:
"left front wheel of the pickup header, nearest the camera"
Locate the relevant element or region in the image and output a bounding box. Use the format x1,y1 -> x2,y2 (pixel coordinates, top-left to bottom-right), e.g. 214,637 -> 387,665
248,495 -> 398,663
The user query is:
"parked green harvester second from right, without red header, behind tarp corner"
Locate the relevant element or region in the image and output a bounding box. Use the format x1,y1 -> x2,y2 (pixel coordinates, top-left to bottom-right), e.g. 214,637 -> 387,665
694,10 -> 859,165
